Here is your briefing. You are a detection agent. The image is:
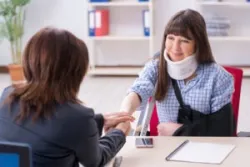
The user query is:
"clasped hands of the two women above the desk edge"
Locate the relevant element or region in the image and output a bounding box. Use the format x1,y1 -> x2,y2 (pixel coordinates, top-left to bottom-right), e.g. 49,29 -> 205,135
103,112 -> 135,136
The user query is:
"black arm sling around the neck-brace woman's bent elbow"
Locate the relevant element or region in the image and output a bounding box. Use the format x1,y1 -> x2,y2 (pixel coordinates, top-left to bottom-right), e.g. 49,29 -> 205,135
173,103 -> 236,136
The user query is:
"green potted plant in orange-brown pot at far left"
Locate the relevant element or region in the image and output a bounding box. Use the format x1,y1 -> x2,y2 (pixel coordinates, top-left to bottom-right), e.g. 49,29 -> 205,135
0,0 -> 30,84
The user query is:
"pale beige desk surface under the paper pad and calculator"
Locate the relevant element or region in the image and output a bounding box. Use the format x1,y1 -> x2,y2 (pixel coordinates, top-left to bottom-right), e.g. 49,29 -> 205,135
117,137 -> 250,167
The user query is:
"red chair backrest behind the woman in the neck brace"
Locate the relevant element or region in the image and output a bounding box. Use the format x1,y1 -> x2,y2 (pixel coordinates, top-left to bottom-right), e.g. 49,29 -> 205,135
150,66 -> 243,136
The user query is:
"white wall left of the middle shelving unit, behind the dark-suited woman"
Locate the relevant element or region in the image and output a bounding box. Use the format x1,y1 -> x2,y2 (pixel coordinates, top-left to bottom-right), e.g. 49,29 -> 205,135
0,0 -> 87,65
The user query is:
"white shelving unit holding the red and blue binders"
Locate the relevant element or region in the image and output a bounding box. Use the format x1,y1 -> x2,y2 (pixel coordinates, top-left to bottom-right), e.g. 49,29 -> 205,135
88,0 -> 154,76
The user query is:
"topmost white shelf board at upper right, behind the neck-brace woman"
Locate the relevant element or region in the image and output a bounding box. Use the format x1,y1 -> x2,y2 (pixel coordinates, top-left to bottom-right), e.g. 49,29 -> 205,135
197,2 -> 250,7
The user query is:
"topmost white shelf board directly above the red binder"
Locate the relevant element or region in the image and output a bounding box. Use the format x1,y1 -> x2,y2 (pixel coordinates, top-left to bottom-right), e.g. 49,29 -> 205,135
89,1 -> 152,7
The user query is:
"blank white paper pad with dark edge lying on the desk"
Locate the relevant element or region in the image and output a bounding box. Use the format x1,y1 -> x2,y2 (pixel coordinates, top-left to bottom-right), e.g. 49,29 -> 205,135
170,141 -> 235,164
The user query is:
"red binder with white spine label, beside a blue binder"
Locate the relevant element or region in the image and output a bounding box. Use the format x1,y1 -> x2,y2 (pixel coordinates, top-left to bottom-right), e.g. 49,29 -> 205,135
95,9 -> 109,36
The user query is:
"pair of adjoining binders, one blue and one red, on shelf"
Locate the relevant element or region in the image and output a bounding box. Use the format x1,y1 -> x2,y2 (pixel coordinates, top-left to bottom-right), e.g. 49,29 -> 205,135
88,9 -> 109,36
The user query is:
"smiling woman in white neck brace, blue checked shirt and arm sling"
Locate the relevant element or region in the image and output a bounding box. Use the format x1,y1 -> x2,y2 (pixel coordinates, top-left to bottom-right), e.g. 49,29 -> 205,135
120,9 -> 235,136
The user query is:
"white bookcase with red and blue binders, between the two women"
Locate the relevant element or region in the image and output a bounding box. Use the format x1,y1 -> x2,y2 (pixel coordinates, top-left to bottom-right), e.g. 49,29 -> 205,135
87,0 -> 154,76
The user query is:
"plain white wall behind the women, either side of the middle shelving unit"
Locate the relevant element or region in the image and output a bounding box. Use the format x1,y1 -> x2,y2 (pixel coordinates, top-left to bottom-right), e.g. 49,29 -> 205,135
0,0 -> 194,65
